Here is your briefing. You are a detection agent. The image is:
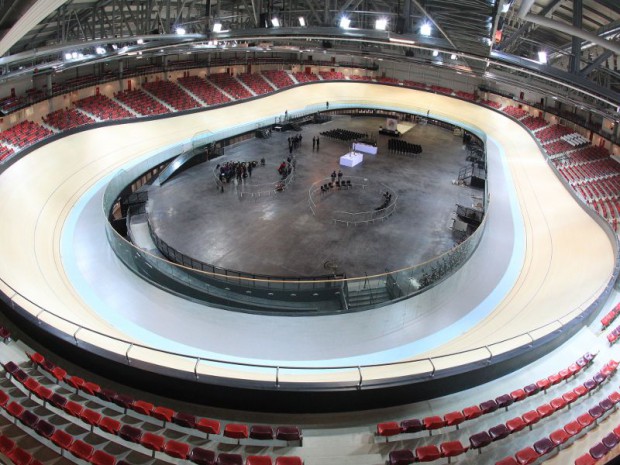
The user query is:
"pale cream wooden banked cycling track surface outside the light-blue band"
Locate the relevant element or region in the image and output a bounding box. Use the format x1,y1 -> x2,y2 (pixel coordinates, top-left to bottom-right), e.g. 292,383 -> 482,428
0,83 -> 615,388
